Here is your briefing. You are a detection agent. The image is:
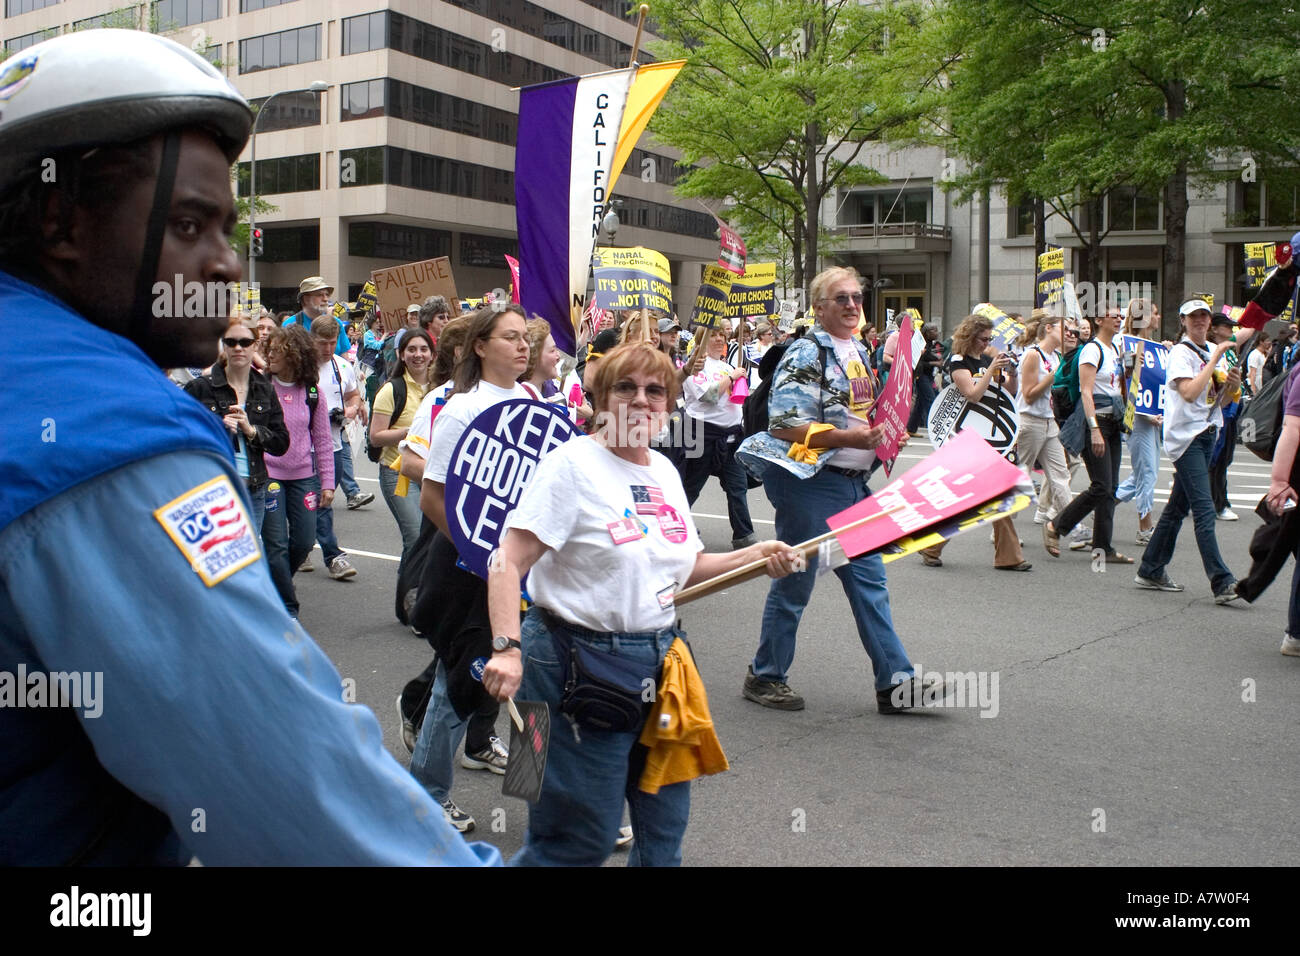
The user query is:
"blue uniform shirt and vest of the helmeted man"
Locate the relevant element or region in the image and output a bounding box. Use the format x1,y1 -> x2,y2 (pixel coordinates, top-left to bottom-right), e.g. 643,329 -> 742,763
0,272 -> 501,866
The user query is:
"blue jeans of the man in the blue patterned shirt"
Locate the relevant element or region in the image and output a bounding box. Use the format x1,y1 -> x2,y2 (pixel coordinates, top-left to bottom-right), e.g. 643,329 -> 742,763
754,466 -> 915,691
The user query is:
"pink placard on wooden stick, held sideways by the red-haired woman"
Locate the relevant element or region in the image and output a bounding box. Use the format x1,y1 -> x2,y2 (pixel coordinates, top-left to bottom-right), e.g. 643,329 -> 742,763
827,429 -> 1023,558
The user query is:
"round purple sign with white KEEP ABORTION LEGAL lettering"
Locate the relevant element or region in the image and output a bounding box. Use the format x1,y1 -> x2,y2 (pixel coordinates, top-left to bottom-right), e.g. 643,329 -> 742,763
446,398 -> 580,578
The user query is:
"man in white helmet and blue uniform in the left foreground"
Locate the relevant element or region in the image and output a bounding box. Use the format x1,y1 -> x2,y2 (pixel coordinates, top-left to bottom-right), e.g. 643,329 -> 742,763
0,30 -> 499,865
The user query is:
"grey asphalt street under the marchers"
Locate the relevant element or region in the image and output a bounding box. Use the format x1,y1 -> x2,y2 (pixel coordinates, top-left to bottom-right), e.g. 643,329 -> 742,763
295,440 -> 1300,866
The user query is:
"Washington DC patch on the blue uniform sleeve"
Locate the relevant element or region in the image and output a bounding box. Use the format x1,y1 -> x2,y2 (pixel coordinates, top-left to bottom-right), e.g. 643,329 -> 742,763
153,475 -> 261,588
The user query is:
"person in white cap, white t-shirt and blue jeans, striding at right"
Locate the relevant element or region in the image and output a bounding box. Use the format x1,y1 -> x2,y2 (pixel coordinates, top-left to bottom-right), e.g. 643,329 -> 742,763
1135,299 -> 1242,604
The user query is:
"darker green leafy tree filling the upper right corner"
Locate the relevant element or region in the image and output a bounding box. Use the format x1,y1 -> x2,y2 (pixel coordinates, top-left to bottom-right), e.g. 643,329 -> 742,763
931,0 -> 1300,335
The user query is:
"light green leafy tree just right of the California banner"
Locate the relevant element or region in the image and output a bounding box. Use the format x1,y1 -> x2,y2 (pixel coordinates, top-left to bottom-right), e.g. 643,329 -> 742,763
650,0 -> 941,287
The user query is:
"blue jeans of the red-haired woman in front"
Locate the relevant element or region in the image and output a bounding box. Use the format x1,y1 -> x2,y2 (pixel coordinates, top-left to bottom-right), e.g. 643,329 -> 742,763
510,607 -> 690,866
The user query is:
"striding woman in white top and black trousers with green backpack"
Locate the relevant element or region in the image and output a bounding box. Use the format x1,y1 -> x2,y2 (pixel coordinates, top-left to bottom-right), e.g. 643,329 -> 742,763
1045,310 -> 1134,564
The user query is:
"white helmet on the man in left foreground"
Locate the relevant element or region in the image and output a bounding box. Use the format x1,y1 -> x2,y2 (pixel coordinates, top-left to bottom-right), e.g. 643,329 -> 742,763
0,30 -> 252,185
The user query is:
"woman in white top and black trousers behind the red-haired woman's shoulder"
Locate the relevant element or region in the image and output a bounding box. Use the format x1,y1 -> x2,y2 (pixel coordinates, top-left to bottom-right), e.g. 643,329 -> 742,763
680,329 -> 754,548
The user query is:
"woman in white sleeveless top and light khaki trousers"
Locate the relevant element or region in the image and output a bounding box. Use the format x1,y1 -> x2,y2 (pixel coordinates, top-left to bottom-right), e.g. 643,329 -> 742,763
1015,308 -> 1070,558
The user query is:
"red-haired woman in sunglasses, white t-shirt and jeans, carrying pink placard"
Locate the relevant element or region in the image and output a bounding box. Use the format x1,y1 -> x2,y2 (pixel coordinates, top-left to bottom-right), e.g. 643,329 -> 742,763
484,343 -> 797,866
